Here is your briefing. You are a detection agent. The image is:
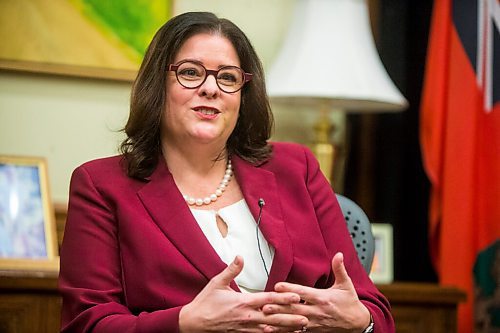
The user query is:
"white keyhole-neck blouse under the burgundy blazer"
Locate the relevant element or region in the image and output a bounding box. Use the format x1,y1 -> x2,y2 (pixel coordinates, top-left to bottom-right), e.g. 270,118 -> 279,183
191,199 -> 274,292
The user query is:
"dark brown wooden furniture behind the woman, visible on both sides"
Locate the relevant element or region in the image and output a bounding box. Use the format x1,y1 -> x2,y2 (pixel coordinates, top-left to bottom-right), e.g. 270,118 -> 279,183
0,271 -> 465,333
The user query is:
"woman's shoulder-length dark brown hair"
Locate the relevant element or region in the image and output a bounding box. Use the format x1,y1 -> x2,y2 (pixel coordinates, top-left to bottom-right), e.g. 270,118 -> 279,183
120,12 -> 274,179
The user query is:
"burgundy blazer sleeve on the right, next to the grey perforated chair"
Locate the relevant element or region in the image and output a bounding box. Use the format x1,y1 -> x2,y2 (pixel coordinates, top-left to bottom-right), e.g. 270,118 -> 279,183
305,149 -> 395,333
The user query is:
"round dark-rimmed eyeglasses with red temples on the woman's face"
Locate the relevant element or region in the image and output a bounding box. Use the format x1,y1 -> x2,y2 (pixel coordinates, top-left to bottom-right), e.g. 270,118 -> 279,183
168,60 -> 252,94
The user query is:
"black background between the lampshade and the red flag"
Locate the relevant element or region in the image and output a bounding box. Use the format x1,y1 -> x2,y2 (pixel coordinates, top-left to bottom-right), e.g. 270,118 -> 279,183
344,0 -> 436,281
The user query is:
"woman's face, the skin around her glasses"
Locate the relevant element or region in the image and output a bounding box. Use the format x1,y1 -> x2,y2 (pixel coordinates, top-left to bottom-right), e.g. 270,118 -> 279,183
162,33 -> 241,149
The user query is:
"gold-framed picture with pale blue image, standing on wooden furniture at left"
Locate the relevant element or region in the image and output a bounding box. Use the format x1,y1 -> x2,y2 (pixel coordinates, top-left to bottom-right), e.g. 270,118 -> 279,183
0,156 -> 59,270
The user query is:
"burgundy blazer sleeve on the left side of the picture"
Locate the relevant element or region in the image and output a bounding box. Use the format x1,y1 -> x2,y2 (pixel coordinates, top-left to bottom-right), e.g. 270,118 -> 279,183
59,166 -> 181,333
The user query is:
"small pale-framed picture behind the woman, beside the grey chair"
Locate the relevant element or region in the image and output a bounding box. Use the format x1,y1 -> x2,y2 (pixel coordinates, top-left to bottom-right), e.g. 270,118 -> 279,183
370,223 -> 394,283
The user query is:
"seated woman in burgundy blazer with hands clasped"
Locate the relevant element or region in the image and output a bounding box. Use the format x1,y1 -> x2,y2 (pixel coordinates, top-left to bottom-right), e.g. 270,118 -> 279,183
59,13 -> 394,332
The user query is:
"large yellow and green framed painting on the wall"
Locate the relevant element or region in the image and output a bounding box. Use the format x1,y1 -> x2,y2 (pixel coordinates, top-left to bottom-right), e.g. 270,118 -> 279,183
0,0 -> 172,81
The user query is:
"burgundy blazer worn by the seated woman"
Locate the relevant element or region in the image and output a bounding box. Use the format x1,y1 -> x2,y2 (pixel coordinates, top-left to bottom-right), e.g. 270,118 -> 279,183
59,143 -> 394,333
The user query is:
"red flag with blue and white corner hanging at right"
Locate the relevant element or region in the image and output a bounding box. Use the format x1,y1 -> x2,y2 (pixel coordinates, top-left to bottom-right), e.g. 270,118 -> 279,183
420,0 -> 500,333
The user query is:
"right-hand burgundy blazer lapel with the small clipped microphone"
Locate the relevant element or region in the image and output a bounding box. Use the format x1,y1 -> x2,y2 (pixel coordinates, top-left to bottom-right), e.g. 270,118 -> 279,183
233,156 -> 293,290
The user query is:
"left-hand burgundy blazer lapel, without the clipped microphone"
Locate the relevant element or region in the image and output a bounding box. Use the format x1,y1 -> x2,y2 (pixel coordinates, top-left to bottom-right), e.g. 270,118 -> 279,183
137,160 -> 228,282
